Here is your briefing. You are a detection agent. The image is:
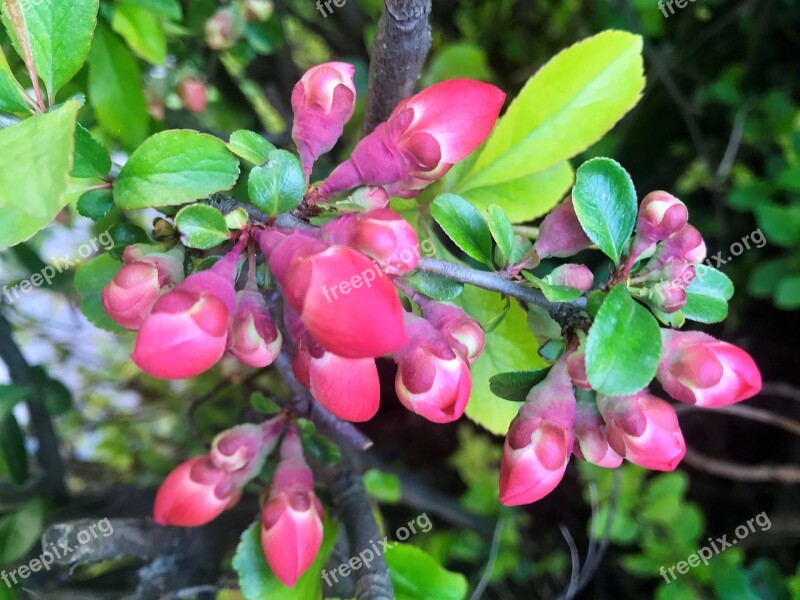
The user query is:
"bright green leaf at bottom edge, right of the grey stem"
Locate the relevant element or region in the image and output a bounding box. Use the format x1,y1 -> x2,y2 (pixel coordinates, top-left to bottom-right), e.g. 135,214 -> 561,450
388,544 -> 467,600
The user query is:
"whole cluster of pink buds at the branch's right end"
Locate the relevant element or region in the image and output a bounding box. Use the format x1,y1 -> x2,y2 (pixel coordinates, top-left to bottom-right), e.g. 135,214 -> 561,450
500,192 -> 761,505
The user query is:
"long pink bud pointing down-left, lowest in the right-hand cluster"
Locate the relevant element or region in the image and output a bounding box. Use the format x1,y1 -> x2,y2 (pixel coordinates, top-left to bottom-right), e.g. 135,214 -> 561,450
500,357 -> 575,506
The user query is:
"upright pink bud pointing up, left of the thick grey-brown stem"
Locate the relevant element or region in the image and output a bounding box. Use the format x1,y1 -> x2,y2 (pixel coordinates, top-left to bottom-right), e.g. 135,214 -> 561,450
292,62 -> 356,177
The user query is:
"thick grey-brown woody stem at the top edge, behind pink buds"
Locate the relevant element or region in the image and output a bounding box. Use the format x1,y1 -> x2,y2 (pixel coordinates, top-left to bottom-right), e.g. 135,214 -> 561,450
364,0 -> 431,134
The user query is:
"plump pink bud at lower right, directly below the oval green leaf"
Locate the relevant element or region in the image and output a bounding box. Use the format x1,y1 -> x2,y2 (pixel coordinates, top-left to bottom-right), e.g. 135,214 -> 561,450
597,390 -> 686,471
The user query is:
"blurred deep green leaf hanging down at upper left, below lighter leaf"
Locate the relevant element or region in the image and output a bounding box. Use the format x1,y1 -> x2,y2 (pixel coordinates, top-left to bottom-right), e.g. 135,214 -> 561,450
88,24 -> 150,148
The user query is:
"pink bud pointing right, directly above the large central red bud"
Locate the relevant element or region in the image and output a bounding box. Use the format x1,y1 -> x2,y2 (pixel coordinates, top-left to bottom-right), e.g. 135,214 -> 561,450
322,208 -> 420,275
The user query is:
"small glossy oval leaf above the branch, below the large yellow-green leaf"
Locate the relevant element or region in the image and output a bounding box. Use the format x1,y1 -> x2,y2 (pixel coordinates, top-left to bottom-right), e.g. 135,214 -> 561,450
430,193 -> 492,266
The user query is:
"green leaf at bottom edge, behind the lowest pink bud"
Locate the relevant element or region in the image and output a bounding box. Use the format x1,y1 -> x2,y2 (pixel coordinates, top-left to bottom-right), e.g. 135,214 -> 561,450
233,519 -> 339,600
